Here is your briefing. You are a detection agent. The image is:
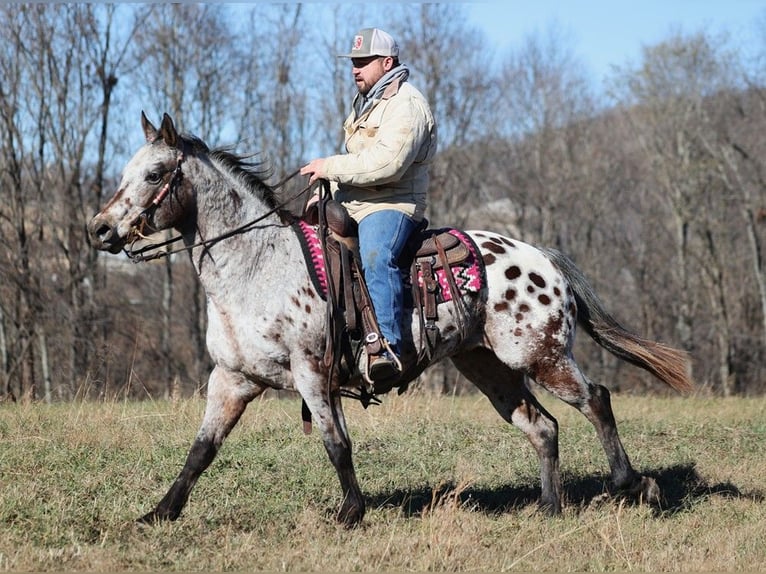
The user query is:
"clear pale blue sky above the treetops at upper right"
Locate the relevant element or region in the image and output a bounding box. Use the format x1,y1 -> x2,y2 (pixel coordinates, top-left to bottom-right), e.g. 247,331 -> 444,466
467,0 -> 766,81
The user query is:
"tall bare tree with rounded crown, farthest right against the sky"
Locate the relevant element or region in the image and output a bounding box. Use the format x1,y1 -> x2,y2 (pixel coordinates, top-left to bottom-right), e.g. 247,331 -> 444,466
608,33 -> 748,394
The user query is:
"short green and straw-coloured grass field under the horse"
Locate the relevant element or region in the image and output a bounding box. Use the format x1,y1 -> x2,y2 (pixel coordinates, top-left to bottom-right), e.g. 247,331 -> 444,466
0,394 -> 766,571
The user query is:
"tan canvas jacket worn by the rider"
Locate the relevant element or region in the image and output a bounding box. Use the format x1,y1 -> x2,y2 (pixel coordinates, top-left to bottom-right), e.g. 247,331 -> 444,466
324,81 -> 436,221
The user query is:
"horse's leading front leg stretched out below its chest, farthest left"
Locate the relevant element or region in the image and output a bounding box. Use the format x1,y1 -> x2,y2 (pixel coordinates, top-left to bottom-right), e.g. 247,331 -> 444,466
139,367 -> 265,524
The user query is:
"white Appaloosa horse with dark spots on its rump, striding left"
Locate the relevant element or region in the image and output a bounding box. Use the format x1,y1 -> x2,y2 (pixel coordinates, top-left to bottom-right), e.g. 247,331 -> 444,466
87,112 -> 693,527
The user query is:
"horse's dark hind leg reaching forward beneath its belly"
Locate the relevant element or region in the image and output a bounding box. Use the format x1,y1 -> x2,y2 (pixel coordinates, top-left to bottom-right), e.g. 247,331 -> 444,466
452,348 -> 561,514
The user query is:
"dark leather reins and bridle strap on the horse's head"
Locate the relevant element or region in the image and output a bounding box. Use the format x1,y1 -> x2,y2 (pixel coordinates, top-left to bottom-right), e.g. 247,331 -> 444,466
123,168 -> 312,263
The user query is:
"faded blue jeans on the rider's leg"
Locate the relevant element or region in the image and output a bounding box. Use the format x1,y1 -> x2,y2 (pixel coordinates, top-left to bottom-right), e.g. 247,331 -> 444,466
359,209 -> 417,353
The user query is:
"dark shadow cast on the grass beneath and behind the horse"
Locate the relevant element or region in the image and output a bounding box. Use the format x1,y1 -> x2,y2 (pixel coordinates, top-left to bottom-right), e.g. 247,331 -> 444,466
368,464 -> 766,517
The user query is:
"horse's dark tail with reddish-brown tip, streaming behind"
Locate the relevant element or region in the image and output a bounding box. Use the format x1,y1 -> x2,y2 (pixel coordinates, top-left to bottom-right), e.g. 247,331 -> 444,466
542,248 -> 693,392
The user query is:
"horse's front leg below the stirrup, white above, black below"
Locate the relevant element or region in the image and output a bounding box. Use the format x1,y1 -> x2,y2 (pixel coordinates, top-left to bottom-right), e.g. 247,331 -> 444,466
297,379 -> 365,527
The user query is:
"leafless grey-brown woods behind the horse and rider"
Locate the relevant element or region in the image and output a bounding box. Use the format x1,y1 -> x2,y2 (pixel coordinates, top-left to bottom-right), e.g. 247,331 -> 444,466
0,3 -> 766,401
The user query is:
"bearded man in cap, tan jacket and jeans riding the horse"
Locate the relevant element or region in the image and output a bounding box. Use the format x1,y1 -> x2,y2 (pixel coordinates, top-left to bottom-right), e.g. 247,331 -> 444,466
301,28 -> 436,381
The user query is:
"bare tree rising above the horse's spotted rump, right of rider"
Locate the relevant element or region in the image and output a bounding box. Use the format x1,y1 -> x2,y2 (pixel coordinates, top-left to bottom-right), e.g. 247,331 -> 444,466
495,22 -> 595,249
